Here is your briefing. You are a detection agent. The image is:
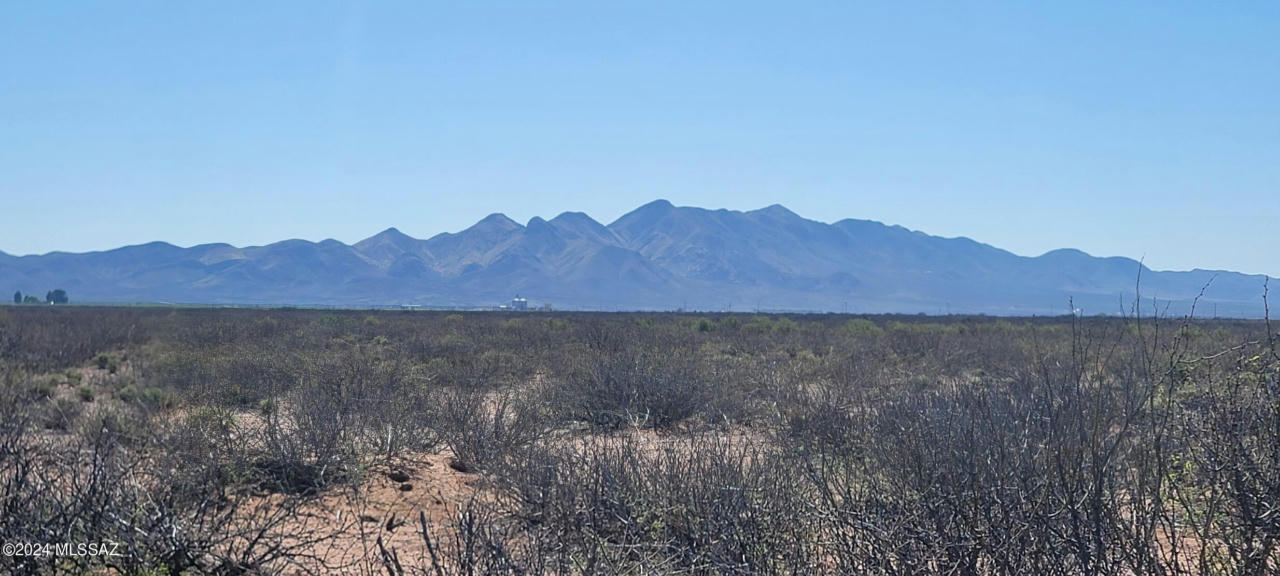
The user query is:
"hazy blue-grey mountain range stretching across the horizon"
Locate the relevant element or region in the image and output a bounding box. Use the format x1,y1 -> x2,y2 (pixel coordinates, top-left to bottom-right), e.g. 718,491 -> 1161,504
0,200 -> 1266,316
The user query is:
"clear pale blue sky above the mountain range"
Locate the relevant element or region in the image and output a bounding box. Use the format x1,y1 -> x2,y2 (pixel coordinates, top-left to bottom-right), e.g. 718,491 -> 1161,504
0,0 -> 1280,275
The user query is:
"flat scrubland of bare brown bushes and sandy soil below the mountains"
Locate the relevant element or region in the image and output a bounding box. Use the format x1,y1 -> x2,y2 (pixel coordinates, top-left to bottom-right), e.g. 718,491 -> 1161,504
0,306 -> 1280,576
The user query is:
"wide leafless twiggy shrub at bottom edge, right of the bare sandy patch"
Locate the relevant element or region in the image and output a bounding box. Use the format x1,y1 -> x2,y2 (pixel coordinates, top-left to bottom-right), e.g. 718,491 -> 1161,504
440,435 -> 817,573
